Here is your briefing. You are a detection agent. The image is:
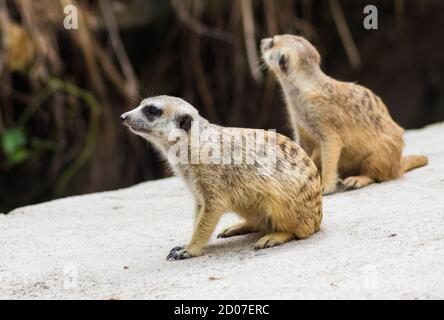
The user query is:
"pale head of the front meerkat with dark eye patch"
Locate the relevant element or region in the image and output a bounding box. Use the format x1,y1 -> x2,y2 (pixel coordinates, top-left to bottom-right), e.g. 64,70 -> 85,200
120,96 -> 199,140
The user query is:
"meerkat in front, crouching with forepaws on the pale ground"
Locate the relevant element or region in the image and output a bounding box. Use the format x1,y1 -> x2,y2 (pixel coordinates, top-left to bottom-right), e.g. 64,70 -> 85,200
121,96 -> 322,260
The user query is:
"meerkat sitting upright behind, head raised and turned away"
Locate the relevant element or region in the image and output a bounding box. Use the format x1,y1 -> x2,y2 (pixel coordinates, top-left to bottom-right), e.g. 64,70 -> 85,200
261,35 -> 428,194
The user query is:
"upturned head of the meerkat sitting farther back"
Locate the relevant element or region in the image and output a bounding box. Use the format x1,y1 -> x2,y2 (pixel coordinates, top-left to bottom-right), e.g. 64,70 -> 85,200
261,34 -> 321,79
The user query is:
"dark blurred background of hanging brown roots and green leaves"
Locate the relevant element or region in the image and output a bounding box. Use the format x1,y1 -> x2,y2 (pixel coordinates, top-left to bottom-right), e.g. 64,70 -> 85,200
0,0 -> 444,212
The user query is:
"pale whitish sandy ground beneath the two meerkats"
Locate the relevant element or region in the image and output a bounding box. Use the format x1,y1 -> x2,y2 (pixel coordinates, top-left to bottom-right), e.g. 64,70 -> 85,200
0,124 -> 444,299
